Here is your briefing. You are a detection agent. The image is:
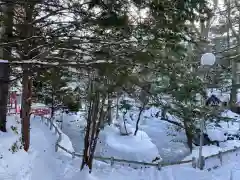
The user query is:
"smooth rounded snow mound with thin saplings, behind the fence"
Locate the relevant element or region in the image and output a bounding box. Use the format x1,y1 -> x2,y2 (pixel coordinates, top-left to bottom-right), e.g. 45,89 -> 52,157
96,126 -> 161,167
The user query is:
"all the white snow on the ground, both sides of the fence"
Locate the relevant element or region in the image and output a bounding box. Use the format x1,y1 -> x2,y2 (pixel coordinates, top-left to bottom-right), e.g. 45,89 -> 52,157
3,109 -> 240,180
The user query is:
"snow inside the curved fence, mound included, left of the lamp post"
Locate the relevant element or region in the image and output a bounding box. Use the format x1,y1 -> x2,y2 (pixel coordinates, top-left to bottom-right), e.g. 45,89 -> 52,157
55,108 -> 190,162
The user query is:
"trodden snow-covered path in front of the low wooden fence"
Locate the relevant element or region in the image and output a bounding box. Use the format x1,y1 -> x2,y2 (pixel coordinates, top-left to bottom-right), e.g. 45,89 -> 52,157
0,114 -> 223,180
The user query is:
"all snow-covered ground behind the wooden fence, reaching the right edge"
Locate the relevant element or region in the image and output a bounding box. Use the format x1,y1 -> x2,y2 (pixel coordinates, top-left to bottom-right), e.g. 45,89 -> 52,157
56,107 -> 240,167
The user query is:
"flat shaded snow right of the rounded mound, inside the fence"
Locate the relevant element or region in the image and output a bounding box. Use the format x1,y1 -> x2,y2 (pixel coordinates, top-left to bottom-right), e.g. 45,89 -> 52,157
120,107 -> 190,162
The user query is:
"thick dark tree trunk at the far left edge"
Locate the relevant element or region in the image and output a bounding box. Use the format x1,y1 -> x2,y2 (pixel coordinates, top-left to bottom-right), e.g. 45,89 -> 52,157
0,0 -> 14,132
